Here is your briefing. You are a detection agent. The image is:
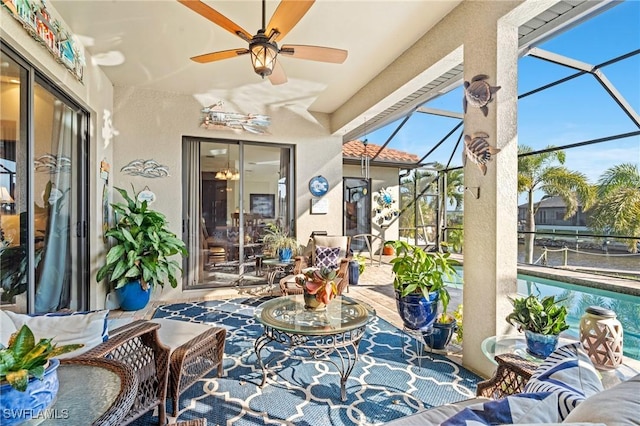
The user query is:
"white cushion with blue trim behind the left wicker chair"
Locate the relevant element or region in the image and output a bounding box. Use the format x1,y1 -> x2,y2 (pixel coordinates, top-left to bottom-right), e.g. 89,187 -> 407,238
7,310 -> 109,359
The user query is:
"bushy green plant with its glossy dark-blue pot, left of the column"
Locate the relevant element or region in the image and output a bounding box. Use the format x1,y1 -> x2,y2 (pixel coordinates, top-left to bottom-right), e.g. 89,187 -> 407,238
385,241 -> 458,333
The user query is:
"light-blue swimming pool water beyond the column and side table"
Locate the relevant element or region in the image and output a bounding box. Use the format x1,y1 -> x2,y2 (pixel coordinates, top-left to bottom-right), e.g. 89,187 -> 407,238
449,268 -> 640,360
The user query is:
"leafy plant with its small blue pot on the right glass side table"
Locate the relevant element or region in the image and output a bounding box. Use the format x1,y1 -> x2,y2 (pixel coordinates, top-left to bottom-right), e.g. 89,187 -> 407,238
507,294 -> 569,358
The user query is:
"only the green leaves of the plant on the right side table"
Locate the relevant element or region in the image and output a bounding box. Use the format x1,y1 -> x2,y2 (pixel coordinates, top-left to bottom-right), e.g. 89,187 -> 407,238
507,294 -> 569,336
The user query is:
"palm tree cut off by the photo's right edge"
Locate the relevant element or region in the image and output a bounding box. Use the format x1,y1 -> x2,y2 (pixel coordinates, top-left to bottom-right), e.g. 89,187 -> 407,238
590,163 -> 640,253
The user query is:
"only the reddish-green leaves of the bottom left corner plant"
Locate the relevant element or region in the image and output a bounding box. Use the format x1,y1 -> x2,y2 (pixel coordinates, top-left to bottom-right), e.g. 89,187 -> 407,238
0,325 -> 84,392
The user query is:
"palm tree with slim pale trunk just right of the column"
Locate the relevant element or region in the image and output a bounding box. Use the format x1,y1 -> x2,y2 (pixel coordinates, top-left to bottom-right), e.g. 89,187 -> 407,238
518,145 -> 593,263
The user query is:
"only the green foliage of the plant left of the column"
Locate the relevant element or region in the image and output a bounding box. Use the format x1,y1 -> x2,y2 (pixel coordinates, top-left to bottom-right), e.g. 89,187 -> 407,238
385,240 -> 458,312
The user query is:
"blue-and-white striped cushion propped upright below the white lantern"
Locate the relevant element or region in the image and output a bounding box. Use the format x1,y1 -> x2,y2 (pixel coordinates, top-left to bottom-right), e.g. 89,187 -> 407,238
524,342 -> 603,420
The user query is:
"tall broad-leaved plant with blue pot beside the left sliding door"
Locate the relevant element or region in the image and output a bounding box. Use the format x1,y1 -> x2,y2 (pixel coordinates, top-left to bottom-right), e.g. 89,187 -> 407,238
96,188 -> 187,311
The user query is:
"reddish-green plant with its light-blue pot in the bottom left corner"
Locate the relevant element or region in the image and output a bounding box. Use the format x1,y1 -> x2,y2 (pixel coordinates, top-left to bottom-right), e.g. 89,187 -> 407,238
0,325 -> 84,425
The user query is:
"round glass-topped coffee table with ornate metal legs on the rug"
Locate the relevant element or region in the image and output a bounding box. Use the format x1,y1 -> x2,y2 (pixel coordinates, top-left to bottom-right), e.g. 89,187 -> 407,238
254,294 -> 376,401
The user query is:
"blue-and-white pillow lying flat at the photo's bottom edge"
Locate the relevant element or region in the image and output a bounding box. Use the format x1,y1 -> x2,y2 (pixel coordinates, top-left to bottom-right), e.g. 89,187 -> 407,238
442,392 -> 560,426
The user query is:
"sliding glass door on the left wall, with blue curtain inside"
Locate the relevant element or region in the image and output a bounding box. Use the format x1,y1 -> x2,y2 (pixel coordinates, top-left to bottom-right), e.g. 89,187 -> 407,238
0,46 -> 88,312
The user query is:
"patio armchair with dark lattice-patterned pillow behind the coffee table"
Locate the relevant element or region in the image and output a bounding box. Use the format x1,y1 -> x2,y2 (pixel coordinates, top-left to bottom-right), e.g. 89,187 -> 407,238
280,235 -> 352,296
